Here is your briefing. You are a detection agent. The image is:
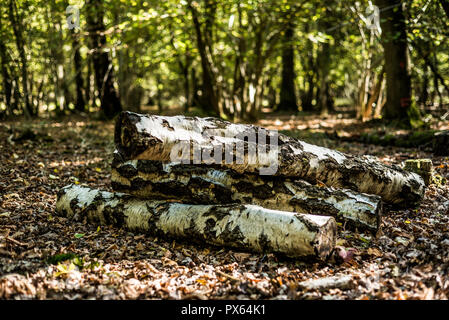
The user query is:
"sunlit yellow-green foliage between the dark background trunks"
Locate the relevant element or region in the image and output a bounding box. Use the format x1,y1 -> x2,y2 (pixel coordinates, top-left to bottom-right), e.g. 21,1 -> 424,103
0,0 -> 449,120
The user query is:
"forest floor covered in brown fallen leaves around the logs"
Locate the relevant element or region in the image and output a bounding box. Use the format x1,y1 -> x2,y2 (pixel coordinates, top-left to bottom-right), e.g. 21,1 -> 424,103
0,113 -> 449,299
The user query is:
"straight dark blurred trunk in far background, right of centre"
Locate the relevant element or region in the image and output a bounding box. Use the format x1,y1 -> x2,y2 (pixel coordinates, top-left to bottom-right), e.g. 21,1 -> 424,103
278,23 -> 298,112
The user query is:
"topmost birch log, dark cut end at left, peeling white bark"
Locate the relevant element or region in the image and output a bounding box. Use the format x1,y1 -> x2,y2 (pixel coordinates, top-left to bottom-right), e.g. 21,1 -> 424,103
114,112 -> 425,205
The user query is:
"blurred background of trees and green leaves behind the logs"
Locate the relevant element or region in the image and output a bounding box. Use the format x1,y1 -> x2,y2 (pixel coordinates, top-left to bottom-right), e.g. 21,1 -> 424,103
0,0 -> 449,126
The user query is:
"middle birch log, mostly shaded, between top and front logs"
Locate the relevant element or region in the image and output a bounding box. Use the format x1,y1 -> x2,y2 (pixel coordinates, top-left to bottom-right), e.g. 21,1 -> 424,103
111,152 -> 382,233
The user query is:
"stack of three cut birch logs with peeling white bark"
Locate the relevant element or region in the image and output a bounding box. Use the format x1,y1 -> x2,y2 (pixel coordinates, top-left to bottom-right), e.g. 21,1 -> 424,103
56,112 -> 425,259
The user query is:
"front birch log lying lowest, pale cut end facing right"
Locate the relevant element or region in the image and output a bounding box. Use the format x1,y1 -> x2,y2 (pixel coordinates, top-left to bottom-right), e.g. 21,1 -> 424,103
56,185 -> 337,259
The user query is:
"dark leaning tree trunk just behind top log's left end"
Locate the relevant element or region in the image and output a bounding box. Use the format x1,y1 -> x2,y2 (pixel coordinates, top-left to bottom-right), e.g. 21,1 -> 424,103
86,0 -> 122,118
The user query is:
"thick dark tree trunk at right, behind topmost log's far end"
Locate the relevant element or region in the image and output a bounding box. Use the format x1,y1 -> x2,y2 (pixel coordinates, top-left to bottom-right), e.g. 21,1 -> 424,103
376,0 -> 412,121
